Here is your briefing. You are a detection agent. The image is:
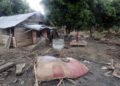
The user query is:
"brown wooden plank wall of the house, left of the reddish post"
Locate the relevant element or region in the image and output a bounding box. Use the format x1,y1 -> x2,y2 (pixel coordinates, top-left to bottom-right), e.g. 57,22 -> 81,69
15,27 -> 33,47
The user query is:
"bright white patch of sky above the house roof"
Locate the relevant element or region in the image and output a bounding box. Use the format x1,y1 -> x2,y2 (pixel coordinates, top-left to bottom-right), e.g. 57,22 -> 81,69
26,0 -> 45,15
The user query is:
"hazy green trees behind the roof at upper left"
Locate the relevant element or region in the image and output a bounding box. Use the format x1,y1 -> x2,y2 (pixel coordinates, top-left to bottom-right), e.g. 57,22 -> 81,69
0,0 -> 30,16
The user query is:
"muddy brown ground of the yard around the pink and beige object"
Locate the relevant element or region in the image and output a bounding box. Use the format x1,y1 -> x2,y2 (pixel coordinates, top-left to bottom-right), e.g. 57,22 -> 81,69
0,40 -> 120,86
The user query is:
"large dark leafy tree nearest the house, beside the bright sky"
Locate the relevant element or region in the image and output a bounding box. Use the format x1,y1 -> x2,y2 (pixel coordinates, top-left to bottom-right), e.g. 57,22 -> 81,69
43,0 -> 95,32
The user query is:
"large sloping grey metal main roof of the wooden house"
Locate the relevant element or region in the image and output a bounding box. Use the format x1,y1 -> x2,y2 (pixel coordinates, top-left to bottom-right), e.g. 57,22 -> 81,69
0,12 -> 41,29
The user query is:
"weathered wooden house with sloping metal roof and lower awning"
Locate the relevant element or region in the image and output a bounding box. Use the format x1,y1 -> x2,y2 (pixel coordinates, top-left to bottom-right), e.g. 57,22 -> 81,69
0,12 -> 53,47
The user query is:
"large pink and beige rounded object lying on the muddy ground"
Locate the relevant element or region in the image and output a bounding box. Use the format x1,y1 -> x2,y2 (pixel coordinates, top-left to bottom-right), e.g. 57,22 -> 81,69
37,56 -> 88,81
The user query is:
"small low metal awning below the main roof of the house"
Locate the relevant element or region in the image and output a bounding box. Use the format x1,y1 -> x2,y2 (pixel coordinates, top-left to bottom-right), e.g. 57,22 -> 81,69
24,24 -> 56,31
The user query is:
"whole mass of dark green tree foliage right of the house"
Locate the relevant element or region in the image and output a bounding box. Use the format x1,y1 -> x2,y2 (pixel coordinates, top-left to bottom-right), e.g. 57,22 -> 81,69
43,0 -> 120,36
